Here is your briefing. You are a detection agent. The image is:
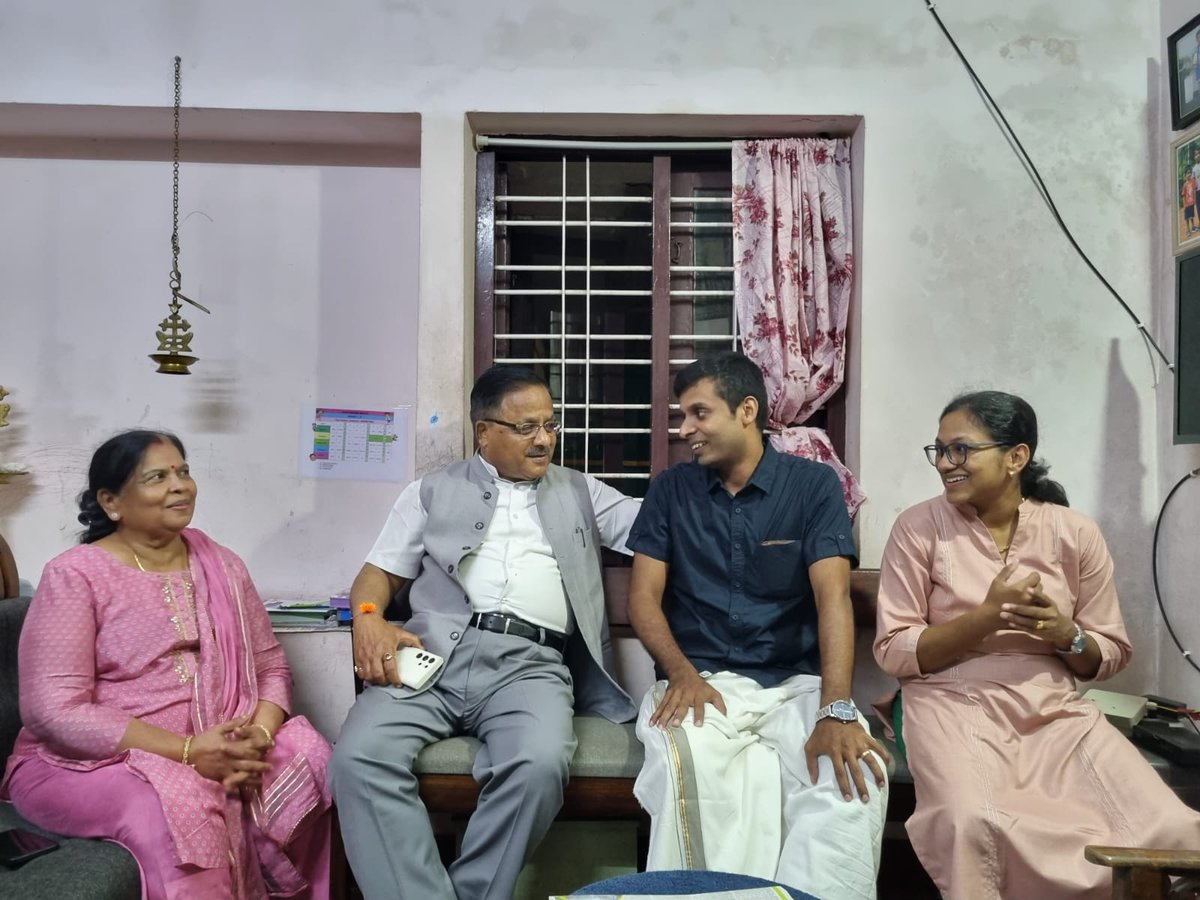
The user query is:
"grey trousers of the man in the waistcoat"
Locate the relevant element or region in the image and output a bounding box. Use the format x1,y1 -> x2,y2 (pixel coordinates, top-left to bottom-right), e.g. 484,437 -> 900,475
329,628 -> 576,900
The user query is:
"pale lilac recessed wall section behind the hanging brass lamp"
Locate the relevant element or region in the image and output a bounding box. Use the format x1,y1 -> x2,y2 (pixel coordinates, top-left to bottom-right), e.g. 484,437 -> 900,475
0,160 -> 419,598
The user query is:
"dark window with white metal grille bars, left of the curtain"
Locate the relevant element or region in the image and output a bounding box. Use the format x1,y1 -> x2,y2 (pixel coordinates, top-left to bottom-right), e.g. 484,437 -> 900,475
475,148 -> 844,497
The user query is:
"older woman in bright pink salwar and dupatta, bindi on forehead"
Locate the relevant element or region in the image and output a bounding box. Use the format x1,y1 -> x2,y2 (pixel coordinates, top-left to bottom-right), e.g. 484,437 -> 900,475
0,431 -> 330,899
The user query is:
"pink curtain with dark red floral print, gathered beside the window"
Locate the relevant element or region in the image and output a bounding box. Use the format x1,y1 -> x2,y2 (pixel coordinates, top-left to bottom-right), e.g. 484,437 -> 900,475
733,138 -> 866,516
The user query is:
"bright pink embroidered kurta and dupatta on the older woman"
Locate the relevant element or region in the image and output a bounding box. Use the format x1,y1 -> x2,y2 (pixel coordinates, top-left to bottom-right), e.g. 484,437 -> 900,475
0,529 -> 330,896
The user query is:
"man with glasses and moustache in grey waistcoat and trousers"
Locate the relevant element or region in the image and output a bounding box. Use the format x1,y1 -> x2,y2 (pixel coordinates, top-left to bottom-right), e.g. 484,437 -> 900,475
330,366 -> 638,900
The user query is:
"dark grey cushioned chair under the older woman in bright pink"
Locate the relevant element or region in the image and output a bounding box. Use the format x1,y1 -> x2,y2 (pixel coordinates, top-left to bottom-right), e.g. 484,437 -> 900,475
0,598 -> 142,900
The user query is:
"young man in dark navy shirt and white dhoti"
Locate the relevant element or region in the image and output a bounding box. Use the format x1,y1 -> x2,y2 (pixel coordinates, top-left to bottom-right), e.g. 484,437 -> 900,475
628,353 -> 888,898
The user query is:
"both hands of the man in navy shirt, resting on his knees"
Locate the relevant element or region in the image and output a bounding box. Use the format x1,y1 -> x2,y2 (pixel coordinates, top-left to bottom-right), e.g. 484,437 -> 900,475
649,670 -> 892,803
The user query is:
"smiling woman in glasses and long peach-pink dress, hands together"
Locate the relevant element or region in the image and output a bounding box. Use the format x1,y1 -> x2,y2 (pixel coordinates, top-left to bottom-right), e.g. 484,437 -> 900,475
875,391 -> 1200,900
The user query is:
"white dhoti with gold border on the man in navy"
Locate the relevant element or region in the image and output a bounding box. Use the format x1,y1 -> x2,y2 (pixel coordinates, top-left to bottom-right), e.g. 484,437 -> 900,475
634,672 -> 888,900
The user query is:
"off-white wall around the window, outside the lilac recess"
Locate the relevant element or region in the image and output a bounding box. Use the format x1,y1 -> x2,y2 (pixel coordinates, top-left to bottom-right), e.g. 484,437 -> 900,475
0,0 -> 1164,686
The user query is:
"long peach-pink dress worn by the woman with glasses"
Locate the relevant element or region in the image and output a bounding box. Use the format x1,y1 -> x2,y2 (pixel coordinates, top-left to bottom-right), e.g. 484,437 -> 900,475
875,496 -> 1200,900
